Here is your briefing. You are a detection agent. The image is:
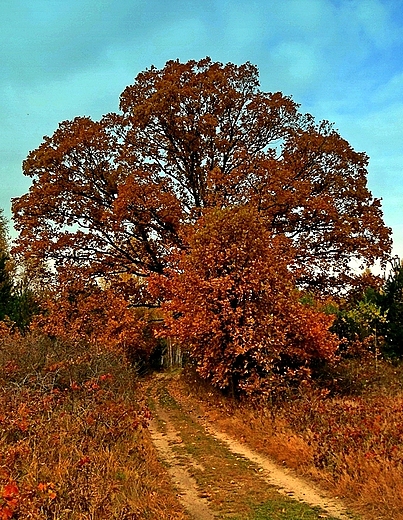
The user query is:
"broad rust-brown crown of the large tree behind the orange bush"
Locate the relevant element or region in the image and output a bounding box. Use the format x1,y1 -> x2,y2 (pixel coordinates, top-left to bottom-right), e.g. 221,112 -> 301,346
13,58 -> 390,296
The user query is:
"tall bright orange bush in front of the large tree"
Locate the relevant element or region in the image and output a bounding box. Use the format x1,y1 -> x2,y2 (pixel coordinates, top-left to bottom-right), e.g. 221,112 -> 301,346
150,206 -> 337,394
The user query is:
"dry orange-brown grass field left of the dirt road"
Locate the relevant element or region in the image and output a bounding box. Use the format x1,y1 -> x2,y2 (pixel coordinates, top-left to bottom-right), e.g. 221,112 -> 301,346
0,336 -> 187,520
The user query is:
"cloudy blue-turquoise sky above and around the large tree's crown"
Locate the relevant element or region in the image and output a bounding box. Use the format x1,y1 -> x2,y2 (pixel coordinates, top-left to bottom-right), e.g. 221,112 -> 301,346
0,0 -> 403,258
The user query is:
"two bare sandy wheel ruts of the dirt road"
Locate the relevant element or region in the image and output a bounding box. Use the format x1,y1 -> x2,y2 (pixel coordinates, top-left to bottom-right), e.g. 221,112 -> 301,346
149,380 -> 360,520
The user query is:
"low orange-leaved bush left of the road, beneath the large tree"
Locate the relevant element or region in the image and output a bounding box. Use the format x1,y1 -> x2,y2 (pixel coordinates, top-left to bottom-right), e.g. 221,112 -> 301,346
31,266 -> 155,368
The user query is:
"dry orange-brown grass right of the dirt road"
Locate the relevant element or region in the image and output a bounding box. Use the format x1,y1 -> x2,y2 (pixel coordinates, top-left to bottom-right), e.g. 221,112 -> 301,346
166,363 -> 403,520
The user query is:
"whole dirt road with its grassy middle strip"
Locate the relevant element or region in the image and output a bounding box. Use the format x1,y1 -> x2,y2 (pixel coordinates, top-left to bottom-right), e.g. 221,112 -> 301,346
149,378 -> 356,520
